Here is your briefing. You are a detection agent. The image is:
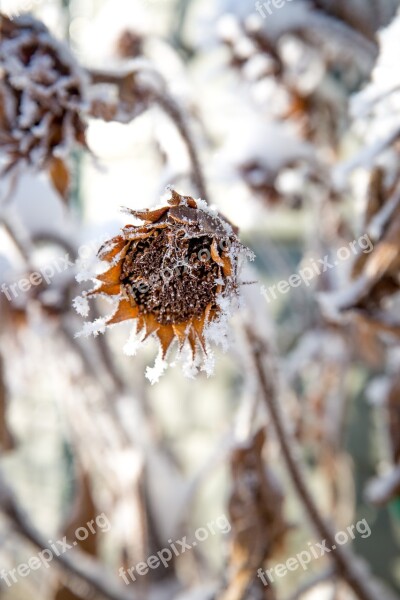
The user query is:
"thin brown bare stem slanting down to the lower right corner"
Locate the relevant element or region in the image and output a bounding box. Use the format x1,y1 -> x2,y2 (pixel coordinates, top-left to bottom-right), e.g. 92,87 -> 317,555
247,327 -> 393,600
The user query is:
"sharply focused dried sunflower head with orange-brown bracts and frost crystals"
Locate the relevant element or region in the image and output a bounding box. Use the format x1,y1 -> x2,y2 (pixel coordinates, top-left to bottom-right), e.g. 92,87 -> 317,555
77,192 -> 250,377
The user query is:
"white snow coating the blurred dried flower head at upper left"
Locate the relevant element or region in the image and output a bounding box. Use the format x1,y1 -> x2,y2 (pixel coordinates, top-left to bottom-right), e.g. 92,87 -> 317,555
0,16 -> 88,169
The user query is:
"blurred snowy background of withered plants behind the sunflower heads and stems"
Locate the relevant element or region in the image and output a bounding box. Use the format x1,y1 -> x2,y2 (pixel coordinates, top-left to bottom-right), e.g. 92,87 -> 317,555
0,0 -> 400,600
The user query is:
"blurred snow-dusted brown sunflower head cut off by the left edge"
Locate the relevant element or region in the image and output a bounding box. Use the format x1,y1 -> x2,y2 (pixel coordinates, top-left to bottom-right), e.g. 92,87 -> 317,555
0,15 -> 86,196
